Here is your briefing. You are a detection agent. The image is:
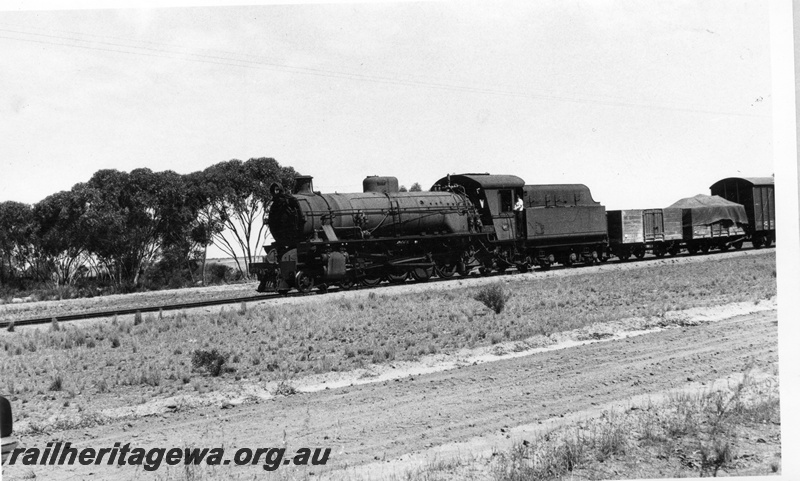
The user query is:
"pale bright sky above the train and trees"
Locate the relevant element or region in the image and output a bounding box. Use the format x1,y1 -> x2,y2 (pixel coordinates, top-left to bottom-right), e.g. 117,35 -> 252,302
0,0 -> 775,209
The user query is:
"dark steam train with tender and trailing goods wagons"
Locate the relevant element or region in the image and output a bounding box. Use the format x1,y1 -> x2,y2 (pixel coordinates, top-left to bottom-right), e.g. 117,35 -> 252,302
249,173 -> 775,293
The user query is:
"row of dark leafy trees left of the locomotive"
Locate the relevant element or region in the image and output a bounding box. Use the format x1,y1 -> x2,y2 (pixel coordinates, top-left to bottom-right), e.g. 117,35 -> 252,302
0,157 -> 296,289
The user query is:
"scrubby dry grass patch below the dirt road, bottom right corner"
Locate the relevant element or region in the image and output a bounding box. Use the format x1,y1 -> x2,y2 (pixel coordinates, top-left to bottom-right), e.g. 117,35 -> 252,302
493,376 -> 780,481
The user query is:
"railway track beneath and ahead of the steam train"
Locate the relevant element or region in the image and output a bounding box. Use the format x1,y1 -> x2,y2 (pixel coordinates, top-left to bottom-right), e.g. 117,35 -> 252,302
0,248 -> 772,329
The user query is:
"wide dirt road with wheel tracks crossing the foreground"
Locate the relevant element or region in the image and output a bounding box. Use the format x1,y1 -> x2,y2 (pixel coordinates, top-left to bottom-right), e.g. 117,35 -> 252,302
4,311 -> 778,479
